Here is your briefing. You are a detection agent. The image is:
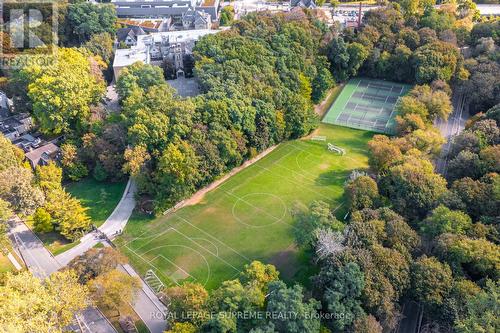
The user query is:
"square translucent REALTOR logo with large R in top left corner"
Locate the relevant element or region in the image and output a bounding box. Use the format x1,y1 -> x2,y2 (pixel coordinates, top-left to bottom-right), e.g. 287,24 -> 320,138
0,0 -> 58,67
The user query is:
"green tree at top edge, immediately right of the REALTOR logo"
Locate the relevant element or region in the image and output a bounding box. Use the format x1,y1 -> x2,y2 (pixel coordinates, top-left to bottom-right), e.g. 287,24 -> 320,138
66,2 -> 117,44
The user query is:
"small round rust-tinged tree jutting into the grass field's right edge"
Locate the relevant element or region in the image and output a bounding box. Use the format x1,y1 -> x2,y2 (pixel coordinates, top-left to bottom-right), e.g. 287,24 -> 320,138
345,176 -> 379,210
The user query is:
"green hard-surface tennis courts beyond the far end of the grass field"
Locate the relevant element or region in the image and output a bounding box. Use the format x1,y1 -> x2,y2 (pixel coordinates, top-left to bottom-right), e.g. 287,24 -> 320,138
323,78 -> 411,134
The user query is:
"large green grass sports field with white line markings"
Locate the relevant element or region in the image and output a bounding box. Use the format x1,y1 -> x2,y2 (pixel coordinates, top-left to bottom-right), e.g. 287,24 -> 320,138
117,124 -> 372,289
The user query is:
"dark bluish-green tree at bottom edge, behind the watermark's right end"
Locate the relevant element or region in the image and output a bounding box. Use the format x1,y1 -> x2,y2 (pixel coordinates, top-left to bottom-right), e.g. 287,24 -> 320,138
323,263 -> 365,331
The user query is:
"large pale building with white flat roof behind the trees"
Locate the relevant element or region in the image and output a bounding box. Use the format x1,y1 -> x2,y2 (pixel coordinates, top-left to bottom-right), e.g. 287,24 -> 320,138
113,29 -> 220,80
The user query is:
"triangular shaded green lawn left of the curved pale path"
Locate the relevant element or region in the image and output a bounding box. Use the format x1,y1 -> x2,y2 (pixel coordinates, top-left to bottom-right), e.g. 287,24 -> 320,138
66,178 -> 127,227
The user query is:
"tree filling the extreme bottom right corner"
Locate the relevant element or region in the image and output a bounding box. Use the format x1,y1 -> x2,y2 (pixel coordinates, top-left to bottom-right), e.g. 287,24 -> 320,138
454,280 -> 500,333
